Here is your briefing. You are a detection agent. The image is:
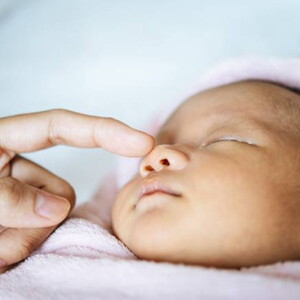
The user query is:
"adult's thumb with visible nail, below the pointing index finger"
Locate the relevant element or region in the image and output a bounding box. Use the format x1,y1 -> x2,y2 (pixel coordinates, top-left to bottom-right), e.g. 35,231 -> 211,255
0,177 -> 71,228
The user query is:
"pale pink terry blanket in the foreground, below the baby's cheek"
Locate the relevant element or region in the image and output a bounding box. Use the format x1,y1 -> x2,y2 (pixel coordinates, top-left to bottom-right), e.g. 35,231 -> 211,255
0,218 -> 300,300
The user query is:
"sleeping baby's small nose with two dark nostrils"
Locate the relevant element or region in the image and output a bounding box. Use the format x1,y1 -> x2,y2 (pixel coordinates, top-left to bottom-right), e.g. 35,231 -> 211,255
139,145 -> 189,177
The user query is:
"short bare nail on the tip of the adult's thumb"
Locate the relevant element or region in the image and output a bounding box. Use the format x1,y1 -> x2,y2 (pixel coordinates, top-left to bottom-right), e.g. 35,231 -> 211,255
35,191 -> 71,219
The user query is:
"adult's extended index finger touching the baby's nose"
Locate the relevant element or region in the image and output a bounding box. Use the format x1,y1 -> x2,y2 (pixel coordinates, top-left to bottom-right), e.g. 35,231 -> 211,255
0,109 -> 154,156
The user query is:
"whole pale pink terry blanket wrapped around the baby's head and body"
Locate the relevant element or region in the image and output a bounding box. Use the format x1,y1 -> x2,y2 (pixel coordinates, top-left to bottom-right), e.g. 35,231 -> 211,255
0,58 -> 300,300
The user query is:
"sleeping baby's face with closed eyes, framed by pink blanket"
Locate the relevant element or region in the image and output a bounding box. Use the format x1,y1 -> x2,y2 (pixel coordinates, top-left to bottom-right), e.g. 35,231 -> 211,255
112,81 -> 300,267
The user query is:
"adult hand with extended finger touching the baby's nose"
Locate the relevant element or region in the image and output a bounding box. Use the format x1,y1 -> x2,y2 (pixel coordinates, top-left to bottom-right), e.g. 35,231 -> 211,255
0,109 -> 154,273
